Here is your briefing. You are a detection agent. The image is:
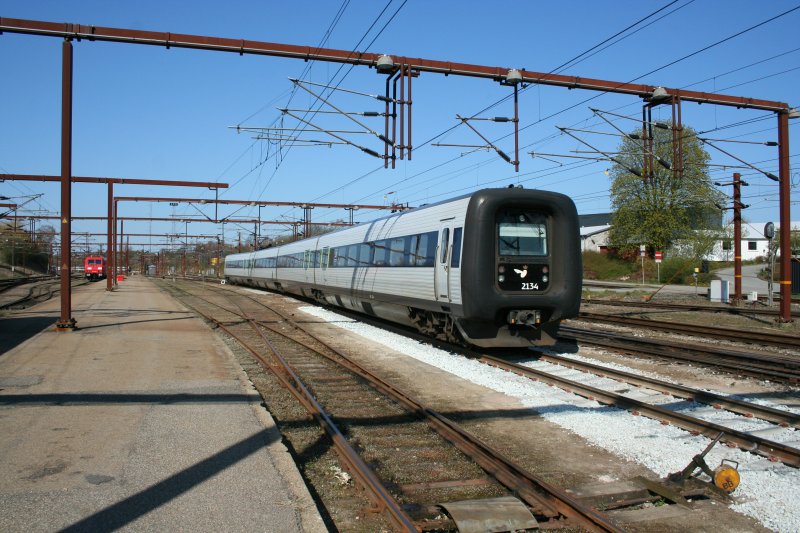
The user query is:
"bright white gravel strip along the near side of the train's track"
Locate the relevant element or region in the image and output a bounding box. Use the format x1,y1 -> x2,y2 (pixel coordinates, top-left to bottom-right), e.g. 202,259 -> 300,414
300,306 -> 800,533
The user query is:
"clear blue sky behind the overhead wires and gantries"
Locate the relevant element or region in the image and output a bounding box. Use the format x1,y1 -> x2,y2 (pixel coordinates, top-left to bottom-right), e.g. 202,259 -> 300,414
0,0 -> 800,249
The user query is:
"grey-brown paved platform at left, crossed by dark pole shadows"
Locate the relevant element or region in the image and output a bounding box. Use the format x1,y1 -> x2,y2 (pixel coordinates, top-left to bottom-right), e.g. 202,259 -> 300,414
0,276 -> 325,532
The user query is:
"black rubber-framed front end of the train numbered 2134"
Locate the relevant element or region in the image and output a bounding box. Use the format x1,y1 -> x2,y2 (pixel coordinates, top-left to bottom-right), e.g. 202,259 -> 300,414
456,188 -> 583,347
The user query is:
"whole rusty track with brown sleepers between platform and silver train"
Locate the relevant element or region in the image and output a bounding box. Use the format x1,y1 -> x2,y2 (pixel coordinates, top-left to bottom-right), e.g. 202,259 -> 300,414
158,284 -> 618,531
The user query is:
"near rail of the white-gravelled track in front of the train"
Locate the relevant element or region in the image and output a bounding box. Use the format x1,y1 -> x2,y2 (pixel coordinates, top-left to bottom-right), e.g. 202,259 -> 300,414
480,355 -> 800,468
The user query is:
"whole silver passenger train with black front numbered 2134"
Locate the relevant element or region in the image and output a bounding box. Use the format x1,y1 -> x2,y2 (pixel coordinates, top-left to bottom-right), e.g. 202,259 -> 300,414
225,188 -> 582,347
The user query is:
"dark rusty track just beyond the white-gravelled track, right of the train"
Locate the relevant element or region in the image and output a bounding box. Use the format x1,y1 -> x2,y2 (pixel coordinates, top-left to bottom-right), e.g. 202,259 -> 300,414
559,326 -> 800,383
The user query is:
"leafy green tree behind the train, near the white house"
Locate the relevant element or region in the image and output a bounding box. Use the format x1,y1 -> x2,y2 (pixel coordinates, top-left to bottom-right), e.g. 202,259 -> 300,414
609,124 -> 725,258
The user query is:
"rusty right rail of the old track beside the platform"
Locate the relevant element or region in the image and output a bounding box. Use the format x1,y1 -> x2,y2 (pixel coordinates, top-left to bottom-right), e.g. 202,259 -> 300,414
189,280 -> 620,531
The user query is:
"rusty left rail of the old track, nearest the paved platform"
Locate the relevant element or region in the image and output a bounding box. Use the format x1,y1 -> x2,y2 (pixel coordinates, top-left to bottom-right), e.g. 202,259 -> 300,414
163,282 -> 418,532
